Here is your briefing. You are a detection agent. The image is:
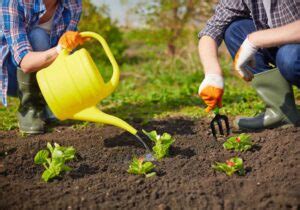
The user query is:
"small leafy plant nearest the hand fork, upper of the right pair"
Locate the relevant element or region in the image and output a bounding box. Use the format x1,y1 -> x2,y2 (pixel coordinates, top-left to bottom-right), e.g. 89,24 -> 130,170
223,133 -> 253,152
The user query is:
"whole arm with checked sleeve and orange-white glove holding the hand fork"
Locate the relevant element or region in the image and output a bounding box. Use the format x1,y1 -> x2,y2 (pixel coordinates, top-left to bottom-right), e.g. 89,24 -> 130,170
198,0 -> 249,112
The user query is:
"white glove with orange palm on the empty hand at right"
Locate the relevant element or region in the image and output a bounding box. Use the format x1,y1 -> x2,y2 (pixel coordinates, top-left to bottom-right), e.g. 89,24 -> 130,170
233,37 -> 258,81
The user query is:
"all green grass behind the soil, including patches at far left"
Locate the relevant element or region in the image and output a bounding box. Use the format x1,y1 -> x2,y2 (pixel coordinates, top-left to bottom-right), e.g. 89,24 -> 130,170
0,29 -> 300,130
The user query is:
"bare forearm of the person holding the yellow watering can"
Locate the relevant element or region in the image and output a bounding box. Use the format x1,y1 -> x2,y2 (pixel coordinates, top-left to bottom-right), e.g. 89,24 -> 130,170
20,48 -> 58,73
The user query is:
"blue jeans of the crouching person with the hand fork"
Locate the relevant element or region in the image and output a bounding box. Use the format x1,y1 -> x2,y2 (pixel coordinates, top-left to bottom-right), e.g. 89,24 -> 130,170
224,19 -> 300,88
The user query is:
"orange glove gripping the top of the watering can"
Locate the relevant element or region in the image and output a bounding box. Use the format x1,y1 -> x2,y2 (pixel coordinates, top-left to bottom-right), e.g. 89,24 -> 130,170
58,31 -> 87,51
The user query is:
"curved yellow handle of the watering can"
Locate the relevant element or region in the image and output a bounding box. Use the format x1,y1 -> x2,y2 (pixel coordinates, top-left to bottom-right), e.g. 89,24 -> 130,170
80,32 -> 120,93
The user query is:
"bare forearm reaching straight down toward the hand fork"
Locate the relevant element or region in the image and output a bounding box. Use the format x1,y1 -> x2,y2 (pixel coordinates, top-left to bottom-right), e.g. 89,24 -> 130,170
199,36 -> 222,75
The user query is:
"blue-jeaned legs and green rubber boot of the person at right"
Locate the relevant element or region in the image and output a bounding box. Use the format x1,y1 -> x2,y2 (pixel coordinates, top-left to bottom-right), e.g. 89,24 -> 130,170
225,20 -> 300,130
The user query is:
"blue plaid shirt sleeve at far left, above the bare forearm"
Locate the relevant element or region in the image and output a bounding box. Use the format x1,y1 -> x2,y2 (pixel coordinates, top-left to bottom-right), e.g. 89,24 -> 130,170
2,0 -> 32,66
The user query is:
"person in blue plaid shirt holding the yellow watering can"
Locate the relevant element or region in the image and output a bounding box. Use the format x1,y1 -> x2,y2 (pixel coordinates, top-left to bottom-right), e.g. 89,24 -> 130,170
0,0 -> 85,134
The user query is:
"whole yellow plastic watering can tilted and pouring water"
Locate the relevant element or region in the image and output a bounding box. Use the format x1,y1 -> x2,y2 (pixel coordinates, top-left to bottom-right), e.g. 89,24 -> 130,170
37,32 -> 137,135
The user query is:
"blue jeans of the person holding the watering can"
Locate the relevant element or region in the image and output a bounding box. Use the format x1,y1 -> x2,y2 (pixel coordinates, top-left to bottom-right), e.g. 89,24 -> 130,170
6,26 -> 51,97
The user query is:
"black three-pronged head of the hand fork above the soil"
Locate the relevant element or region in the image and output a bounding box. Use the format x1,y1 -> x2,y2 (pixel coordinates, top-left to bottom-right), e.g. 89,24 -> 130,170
210,108 -> 230,138
